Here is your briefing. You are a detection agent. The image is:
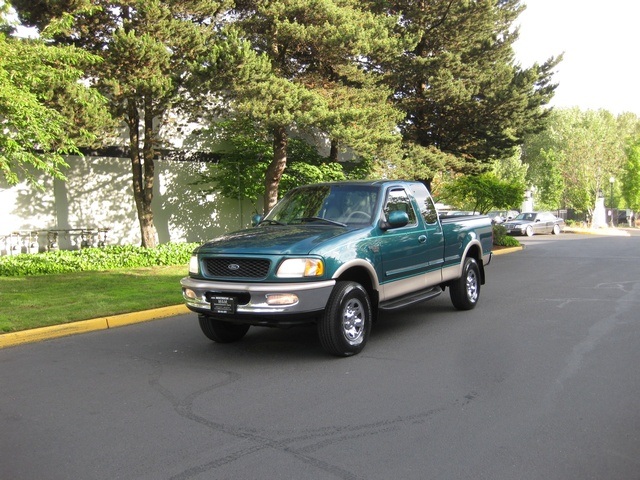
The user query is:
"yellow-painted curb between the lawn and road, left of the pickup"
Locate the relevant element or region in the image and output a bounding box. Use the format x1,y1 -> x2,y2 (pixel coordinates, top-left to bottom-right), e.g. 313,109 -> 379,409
0,305 -> 190,349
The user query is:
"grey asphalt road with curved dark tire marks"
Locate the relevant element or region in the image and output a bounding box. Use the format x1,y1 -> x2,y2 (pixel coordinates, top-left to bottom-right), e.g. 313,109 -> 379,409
0,233 -> 640,480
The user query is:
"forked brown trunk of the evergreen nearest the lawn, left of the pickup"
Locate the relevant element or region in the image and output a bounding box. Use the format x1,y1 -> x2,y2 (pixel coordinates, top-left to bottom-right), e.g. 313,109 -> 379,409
127,100 -> 158,248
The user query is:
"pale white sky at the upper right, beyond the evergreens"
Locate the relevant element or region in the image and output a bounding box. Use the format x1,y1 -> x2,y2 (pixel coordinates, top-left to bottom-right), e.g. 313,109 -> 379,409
514,0 -> 640,116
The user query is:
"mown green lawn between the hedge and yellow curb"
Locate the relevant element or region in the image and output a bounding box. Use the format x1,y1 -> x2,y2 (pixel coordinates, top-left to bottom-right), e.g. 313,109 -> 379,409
0,265 -> 187,334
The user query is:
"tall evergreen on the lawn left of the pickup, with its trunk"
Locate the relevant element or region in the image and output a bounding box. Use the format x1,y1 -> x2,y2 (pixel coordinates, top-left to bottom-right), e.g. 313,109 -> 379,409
12,0 -> 234,247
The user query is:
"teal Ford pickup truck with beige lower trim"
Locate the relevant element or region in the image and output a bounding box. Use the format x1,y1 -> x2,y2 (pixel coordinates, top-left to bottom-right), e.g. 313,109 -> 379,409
181,180 -> 493,356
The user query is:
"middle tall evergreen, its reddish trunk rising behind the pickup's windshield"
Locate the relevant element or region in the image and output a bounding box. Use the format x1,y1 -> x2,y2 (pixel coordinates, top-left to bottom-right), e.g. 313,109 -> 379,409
216,0 -> 401,210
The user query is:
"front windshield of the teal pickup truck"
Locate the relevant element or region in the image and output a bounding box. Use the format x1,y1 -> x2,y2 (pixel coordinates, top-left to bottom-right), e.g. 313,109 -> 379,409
264,184 -> 378,226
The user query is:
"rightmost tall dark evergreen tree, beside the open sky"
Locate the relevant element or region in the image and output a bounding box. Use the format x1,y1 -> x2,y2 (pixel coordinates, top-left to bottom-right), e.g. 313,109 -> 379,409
368,0 -> 560,179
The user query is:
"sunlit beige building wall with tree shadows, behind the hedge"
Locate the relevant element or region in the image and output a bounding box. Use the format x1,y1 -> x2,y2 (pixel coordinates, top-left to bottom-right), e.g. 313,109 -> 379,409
0,157 -> 254,254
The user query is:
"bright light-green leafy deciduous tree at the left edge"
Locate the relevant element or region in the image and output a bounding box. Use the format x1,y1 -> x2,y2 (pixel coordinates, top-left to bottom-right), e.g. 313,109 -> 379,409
0,5 -> 107,184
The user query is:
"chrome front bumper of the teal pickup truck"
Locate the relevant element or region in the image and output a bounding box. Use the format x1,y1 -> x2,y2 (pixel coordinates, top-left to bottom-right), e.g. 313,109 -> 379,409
180,277 -> 336,324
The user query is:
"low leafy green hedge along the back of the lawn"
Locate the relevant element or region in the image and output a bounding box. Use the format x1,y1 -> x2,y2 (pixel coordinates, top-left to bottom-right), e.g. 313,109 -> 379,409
0,243 -> 198,277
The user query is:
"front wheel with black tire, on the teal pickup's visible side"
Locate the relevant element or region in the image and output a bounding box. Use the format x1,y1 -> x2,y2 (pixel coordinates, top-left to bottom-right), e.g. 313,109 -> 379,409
318,281 -> 372,357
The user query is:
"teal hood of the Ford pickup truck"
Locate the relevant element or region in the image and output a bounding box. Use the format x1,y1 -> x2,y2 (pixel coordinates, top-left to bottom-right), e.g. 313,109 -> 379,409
197,225 -> 350,255
